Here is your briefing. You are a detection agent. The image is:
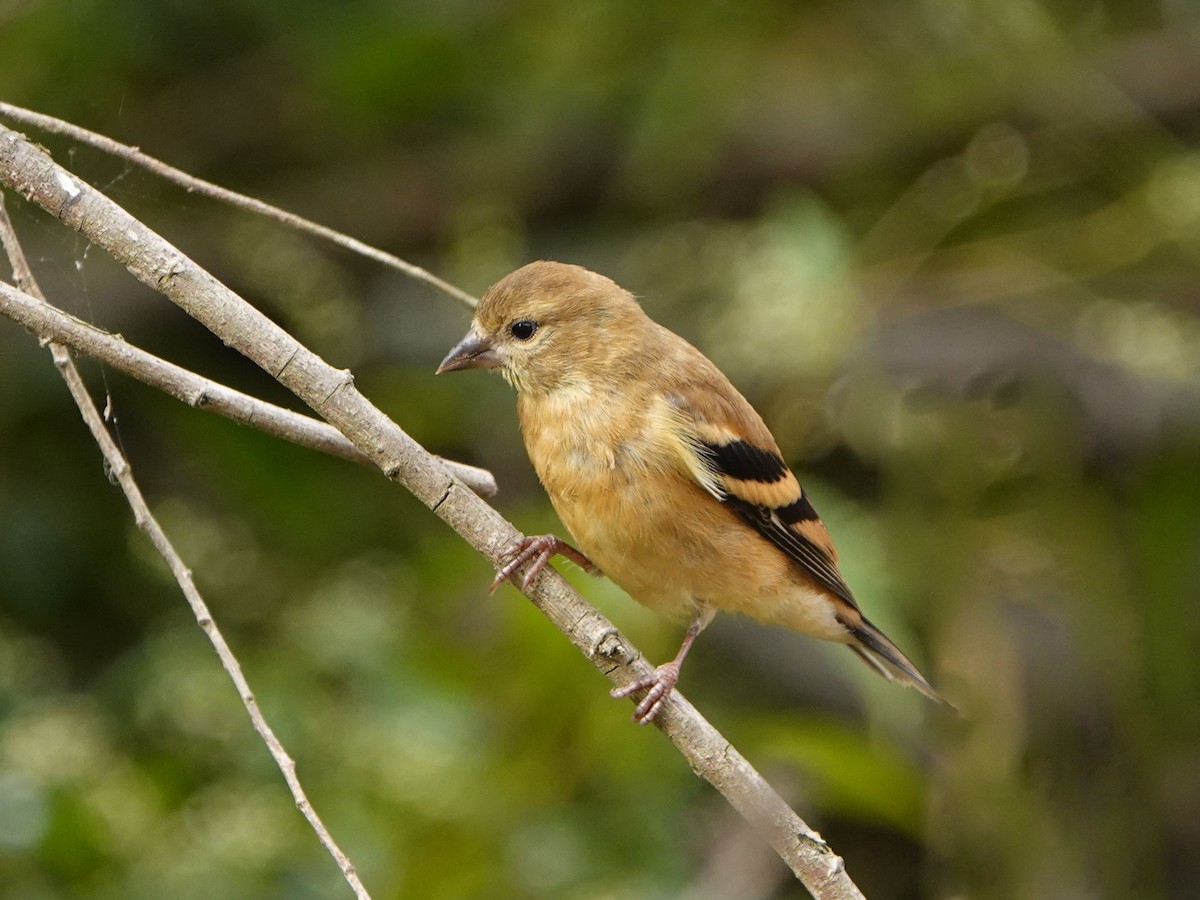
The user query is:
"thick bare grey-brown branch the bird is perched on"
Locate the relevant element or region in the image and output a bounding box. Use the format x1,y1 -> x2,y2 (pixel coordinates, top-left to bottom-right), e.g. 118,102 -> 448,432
0,128 -> 862,900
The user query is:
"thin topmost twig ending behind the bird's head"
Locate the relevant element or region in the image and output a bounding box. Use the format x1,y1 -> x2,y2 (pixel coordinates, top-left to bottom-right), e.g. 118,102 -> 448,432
0,102 -> 479,308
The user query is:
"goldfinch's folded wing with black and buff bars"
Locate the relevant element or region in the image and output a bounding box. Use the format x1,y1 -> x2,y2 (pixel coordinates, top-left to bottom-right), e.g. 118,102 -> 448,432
666,374 -> 857,608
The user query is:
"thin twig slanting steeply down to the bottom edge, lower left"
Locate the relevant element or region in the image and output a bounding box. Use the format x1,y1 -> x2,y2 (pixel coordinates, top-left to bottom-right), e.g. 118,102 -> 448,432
0,193 -> 371,900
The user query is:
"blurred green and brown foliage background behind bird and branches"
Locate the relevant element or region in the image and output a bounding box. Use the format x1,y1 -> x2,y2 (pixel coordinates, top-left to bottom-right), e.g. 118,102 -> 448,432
0,0 -> 1200,900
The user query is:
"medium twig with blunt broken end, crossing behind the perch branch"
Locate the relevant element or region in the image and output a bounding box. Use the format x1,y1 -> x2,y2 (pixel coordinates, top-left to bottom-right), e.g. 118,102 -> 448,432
0,282 -> 497,497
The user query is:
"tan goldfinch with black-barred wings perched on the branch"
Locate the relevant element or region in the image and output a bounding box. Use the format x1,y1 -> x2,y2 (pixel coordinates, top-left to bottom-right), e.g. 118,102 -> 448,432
438,262 -> 946,725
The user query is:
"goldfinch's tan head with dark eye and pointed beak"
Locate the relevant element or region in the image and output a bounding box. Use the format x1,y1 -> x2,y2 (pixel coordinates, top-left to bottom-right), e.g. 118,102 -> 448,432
438,262 -> 648,394
